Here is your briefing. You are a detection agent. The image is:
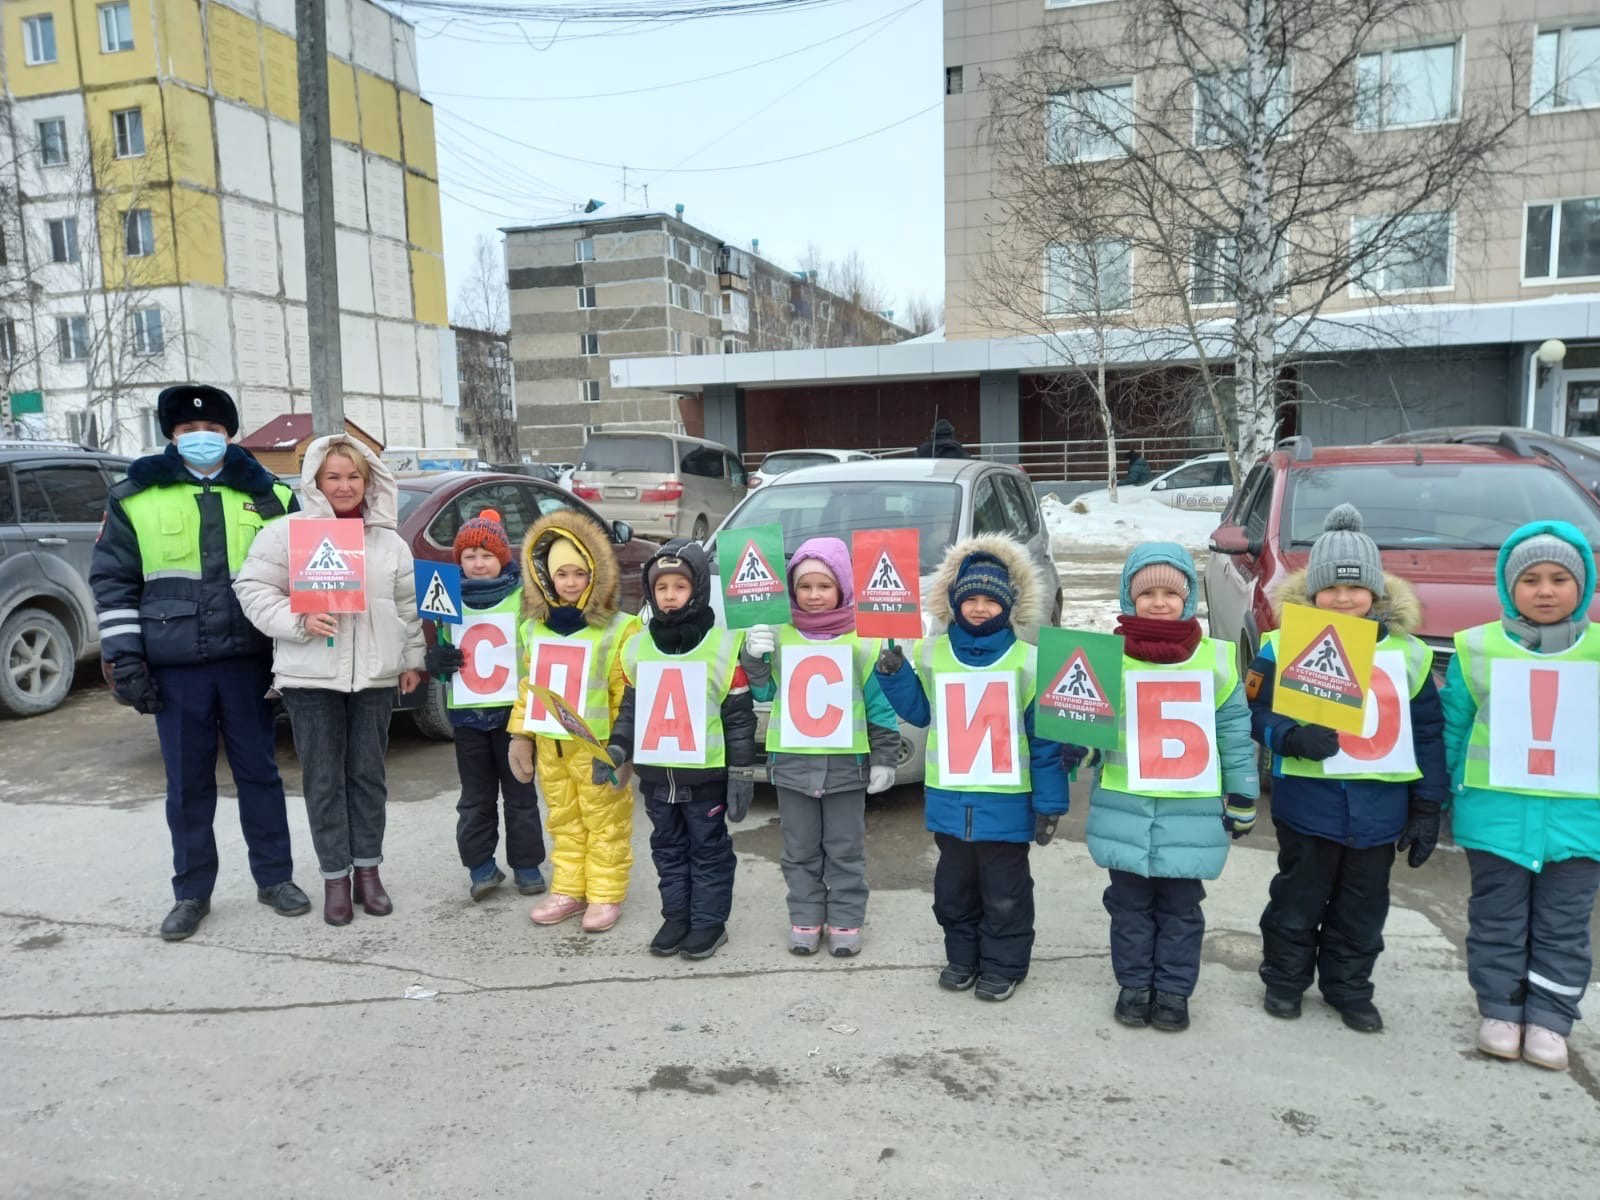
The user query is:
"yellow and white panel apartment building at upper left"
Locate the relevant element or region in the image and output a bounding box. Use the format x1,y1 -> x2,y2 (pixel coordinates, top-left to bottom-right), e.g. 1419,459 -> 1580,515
0,0 -> 458,453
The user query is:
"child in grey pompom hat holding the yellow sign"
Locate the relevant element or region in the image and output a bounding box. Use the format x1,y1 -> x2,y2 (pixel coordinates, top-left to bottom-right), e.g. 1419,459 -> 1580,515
1245,504 -> 1448,1034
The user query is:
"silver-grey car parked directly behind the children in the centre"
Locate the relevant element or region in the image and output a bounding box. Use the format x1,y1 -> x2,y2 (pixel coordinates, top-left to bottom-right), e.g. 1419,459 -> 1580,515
712,458 -> 1061,782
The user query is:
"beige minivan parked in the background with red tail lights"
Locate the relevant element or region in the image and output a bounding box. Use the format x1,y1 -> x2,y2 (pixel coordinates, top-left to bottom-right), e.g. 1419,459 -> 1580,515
573,430 -> 749,541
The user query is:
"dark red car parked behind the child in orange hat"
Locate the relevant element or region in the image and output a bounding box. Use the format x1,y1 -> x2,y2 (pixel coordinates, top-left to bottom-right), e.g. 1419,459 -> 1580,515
398,470 -> 658,739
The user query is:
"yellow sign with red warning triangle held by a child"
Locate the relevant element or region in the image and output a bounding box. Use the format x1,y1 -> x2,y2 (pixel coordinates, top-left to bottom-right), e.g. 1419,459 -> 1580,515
1272,605 -> 1378,733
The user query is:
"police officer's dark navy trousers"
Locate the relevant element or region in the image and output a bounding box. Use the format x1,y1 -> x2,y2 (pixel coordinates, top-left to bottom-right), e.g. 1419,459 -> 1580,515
150,658 -> 294,899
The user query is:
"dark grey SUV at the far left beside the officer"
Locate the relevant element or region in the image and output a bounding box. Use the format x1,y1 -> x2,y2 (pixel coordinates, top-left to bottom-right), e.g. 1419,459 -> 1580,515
0,442 -> 131,717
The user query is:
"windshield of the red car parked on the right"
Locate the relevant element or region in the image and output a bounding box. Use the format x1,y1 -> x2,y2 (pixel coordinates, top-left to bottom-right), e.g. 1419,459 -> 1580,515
1283,462 -> 1600,550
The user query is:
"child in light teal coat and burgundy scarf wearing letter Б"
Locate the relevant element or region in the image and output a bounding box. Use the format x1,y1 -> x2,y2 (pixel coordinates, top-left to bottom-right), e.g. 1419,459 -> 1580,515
1062,542 -> 1259,1032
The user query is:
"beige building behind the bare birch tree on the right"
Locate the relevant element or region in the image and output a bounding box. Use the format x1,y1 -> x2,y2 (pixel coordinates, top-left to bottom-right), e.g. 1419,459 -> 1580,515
944,0 -> 1600,440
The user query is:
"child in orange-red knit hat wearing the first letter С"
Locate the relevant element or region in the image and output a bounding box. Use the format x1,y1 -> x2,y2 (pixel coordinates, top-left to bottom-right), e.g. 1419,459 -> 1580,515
427,509 -> 544,901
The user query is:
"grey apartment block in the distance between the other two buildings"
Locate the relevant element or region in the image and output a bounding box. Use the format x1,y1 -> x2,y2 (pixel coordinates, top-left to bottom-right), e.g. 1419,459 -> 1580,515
502,211 -> 909,462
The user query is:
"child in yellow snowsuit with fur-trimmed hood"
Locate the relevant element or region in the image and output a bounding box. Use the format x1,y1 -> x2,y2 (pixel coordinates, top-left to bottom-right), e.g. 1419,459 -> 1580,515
509,512 -> 638,933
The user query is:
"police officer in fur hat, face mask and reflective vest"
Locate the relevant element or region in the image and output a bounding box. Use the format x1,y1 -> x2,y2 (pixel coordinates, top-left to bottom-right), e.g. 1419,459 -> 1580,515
90,384 -> 310,941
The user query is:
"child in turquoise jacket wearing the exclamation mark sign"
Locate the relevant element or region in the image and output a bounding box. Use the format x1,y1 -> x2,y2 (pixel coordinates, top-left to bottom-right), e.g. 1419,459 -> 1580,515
1445,522 -> 1600,1070
